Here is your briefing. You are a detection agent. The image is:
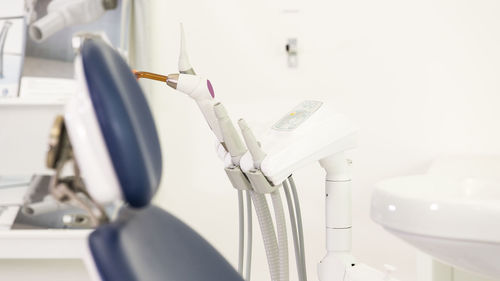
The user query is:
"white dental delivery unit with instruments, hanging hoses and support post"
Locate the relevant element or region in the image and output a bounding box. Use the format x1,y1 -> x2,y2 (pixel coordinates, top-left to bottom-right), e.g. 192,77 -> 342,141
129,25 -> 395,281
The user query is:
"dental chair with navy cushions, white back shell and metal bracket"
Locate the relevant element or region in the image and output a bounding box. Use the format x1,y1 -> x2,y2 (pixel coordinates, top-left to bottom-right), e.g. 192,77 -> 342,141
51,39 -> 243,281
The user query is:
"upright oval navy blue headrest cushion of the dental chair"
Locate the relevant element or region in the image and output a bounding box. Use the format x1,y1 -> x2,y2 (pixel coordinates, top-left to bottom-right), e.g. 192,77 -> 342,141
81,39 -> 162,207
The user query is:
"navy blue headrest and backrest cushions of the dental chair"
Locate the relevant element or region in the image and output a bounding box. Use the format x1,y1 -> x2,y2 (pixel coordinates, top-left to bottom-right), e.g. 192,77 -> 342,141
81,40 -> 243,281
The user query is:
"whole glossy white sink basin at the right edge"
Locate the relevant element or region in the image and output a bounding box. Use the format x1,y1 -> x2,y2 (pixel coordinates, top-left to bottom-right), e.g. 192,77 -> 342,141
371,157 -> 500,278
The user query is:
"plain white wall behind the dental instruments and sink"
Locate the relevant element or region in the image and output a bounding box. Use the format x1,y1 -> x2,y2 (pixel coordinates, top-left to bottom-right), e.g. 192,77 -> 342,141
147,0 -> 500,281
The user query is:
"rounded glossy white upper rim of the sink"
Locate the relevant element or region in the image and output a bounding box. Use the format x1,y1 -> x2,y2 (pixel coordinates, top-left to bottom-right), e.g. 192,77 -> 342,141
371,174 -> 500,243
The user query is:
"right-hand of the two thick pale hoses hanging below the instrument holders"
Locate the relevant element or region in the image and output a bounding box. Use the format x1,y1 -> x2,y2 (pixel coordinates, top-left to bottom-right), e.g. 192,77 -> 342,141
271,190 -> 289,281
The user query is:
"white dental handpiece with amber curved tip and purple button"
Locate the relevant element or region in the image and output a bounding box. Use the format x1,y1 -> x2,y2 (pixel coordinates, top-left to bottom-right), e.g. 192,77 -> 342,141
133,70 -> 224,144
